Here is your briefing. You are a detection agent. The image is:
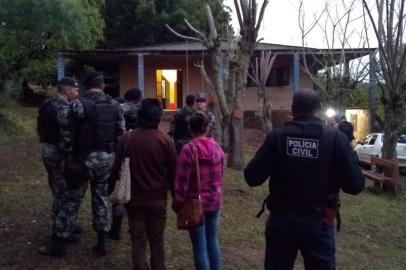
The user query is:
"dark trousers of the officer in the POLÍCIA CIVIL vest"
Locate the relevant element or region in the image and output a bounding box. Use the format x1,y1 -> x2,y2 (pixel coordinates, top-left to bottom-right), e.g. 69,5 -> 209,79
265,213 -> 336,270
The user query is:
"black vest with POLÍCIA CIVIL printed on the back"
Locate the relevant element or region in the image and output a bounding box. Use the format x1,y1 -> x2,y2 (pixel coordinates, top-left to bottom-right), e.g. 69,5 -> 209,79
268,121 -> 339,212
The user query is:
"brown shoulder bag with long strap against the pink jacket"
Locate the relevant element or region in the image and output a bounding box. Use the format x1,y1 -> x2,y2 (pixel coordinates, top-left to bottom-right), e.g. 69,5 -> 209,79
176,145 -> 204,230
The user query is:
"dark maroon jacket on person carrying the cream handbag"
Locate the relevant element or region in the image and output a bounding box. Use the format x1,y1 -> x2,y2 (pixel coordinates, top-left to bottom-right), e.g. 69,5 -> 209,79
109,128 -> 176,206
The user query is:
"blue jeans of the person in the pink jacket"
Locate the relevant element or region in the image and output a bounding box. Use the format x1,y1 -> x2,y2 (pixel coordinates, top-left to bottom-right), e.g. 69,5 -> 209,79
189,210 -> 221,270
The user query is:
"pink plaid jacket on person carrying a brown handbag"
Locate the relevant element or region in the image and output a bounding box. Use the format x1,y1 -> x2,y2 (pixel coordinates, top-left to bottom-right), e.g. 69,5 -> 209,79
173,138 -> 224,212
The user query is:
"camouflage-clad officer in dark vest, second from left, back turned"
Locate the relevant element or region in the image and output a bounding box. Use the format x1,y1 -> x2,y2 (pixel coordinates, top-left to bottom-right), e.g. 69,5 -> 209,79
71,72 -> 125,256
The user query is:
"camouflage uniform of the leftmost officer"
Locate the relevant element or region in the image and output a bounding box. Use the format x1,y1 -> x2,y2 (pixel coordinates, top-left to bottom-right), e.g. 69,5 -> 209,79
38,95 -> 77,234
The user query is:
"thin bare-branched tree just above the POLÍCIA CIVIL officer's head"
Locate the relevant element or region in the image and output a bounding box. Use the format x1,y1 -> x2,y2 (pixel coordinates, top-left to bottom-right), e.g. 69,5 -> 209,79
298,0 -> 369,112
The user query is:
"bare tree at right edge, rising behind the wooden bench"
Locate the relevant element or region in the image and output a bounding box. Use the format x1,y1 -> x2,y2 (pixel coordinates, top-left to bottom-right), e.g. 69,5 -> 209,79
362,0 -> 406,165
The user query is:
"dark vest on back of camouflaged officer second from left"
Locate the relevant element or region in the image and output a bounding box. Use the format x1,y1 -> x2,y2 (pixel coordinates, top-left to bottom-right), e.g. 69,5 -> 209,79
75,93 -> 119,153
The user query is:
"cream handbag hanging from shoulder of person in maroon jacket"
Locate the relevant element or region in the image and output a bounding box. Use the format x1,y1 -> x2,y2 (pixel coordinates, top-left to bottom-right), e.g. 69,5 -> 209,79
109,131 -> 131,204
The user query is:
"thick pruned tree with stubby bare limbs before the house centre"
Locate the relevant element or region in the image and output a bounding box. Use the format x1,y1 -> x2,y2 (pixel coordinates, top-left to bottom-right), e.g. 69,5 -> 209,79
167,0 -> 268,169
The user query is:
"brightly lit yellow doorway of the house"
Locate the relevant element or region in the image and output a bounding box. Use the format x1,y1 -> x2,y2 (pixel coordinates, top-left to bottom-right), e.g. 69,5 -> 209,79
156,69 -> 182,111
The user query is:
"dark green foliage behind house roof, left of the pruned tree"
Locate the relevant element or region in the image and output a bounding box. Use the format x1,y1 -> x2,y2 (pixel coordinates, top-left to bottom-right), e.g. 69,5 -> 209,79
102,0 -> 230,48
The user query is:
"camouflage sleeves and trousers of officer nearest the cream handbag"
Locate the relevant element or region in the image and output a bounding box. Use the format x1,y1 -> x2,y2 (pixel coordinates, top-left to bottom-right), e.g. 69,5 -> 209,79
67,91 -> 125,233
